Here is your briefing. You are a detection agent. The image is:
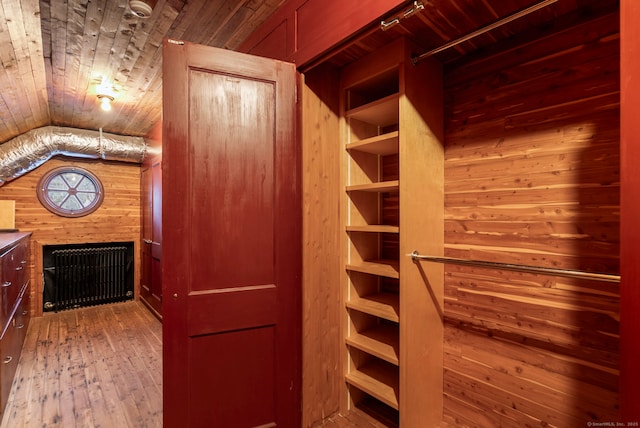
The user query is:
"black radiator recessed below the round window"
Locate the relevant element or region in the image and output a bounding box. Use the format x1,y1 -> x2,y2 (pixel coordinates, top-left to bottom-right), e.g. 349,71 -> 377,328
43,246 -> 133,311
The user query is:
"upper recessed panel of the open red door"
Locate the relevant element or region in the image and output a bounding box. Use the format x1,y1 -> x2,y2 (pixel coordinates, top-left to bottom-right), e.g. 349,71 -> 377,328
189,70 -> 275,291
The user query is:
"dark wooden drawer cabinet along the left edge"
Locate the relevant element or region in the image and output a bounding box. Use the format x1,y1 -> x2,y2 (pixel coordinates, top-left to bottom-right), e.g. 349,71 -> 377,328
0,233 -> 31,412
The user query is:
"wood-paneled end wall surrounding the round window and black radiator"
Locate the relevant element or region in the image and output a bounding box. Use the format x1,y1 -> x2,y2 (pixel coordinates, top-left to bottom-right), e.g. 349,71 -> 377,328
0,156 -> 141,315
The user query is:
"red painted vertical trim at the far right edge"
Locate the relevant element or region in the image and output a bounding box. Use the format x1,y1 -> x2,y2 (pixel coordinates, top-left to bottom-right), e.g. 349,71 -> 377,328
620,0 -> 640,423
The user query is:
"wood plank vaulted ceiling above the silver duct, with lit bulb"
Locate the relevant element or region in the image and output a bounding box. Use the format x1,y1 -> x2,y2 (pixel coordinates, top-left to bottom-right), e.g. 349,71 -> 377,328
0,0 -> 283,143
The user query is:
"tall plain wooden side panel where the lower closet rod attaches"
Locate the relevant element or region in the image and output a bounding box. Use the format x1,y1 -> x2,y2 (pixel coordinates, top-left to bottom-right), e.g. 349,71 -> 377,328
399,42 -> 445,427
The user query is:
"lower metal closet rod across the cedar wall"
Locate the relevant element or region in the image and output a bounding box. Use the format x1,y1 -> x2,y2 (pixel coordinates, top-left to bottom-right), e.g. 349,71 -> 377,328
407,251 -> 620,283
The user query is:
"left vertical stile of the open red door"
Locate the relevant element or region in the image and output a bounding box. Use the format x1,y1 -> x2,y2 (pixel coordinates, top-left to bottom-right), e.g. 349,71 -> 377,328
162,39 -> 191,428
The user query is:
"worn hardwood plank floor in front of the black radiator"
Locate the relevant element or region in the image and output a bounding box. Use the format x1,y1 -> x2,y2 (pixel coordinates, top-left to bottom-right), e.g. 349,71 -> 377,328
0,302 -> 162,428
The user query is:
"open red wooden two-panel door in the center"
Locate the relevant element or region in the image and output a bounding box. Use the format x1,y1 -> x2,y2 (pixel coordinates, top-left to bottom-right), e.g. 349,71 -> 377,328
162,40 -> 301,428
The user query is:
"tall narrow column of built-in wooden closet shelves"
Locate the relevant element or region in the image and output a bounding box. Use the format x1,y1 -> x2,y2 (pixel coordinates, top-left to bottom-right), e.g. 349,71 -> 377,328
343,37 -> 400,419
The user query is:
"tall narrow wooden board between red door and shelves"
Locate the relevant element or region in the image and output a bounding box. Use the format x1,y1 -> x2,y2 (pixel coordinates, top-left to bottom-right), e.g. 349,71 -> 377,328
301,62 -> 343,427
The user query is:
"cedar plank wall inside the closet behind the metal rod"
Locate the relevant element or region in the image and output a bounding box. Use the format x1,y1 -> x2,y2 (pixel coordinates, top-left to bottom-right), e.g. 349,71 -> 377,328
444,10 -> 620,427
